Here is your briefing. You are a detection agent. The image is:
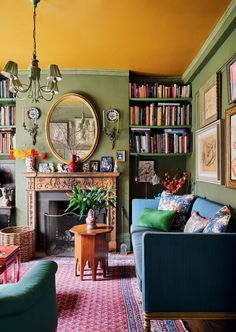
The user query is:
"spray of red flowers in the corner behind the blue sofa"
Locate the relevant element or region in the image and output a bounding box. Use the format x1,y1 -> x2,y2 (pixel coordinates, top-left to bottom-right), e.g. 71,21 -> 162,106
160,170 -> 188,194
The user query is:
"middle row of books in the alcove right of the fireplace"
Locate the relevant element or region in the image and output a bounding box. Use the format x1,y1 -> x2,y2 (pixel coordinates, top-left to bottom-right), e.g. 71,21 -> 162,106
129,103 -> 192,126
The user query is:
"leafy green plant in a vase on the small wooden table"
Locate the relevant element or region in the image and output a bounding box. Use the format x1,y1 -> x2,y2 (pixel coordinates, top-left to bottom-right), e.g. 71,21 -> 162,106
66,185 -> 116,229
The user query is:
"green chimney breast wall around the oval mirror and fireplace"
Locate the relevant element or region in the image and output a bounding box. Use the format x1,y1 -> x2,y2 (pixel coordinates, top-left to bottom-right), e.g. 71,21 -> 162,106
16,70 -> 130,250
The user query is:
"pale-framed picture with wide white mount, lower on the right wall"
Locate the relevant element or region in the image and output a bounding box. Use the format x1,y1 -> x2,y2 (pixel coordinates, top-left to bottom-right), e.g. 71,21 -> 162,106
196,120 -> 223,184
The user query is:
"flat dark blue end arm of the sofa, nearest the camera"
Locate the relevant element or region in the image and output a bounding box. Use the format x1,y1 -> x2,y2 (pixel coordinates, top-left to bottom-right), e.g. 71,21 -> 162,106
142,232 -> 236,313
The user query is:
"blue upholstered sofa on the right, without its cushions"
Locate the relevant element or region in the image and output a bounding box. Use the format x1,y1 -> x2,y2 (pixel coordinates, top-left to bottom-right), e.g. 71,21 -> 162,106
131,197 -> 236,332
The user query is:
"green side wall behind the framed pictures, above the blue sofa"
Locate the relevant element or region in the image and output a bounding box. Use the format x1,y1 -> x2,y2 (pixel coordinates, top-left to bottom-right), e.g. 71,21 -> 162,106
187,25 -> 236,207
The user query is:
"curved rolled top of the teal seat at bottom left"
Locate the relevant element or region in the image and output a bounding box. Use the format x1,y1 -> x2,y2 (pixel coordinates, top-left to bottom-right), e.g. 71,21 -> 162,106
0,260 -> 57,317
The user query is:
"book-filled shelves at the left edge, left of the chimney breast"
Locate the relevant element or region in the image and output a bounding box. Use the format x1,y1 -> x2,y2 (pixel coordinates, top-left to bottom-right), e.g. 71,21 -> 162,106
0,77 -> 16,158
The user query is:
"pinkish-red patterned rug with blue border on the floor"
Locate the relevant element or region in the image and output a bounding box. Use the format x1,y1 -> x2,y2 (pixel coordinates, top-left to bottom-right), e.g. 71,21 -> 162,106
21,254 -> 187,332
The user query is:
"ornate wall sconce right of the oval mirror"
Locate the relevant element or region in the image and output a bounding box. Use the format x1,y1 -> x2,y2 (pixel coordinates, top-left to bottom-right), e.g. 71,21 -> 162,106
103,108 -> 120,150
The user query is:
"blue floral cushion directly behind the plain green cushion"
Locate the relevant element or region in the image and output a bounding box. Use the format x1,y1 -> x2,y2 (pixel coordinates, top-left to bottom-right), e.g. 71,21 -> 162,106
158,191 -> 194,231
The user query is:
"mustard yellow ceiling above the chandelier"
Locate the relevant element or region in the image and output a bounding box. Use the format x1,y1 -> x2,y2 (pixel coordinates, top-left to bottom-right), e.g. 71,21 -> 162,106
0,0 -> 230,75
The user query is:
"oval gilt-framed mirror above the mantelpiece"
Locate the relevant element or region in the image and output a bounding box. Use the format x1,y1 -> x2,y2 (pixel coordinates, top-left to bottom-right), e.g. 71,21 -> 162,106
46,93 -> 99,163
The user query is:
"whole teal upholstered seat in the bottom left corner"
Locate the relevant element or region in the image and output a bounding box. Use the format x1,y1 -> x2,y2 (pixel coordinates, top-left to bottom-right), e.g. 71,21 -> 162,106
0,260 -> 57,332
